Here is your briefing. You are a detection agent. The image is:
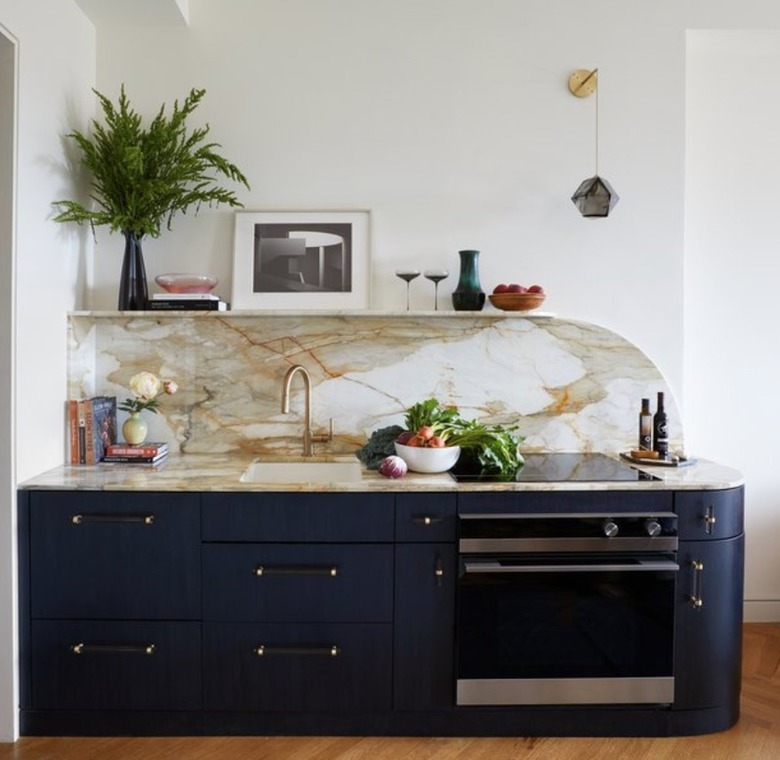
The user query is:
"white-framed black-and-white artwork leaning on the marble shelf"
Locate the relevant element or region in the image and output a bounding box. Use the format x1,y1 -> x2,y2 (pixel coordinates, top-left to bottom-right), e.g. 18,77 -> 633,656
232,211 -> 370,310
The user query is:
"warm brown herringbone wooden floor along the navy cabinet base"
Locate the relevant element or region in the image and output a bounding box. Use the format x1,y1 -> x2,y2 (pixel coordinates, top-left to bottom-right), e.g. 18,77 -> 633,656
0,623 -> 780,760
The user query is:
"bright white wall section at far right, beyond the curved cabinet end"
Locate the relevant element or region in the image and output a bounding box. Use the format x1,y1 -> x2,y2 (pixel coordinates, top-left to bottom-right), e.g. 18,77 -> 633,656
685,30 -> 780,620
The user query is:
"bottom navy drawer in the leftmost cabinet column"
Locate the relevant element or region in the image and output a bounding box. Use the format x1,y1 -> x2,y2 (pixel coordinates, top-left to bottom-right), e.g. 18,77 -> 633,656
31,621 -> 201,710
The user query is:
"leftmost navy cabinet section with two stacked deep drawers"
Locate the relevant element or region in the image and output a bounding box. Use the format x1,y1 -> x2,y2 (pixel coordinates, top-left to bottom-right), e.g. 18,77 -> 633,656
19,491 -> 201,733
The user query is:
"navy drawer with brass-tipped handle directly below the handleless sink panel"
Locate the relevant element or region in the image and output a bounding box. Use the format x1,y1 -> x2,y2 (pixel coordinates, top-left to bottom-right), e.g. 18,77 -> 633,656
203,544 -> 393,622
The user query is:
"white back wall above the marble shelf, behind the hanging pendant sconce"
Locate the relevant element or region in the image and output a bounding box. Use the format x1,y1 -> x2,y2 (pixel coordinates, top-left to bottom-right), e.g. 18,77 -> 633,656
91,0 -> 684,391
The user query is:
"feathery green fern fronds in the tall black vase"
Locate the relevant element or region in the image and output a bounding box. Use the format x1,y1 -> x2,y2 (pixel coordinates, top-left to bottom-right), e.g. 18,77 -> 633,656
53,85 -> 249,239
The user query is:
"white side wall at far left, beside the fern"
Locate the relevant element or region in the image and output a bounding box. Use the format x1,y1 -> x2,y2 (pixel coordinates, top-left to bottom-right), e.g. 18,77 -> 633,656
0,0 -> 95,741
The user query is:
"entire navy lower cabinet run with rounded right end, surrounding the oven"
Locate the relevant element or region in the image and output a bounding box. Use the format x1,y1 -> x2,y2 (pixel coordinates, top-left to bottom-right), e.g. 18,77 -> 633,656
18,488 -> 744,736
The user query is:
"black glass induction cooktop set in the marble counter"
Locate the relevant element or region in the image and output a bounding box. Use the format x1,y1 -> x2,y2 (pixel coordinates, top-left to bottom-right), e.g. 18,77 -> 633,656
450,452 -> 658,483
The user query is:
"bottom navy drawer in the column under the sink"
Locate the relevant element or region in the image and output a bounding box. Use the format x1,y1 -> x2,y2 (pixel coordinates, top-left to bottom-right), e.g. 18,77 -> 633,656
203,623 -> 393,713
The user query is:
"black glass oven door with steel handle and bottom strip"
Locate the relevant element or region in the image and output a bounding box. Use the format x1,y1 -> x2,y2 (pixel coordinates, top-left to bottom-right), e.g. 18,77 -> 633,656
457,552 -> 679,704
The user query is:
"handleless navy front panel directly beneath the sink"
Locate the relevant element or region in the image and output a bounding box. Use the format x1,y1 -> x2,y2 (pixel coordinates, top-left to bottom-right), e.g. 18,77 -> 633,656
203,492 -> 395,542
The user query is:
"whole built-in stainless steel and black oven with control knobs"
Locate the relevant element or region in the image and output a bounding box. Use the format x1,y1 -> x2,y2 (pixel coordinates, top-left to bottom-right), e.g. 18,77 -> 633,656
456,504 -> 679,705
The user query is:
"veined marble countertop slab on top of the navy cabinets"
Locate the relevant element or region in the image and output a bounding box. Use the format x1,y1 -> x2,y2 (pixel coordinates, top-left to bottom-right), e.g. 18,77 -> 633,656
19,454 -> 744,492
